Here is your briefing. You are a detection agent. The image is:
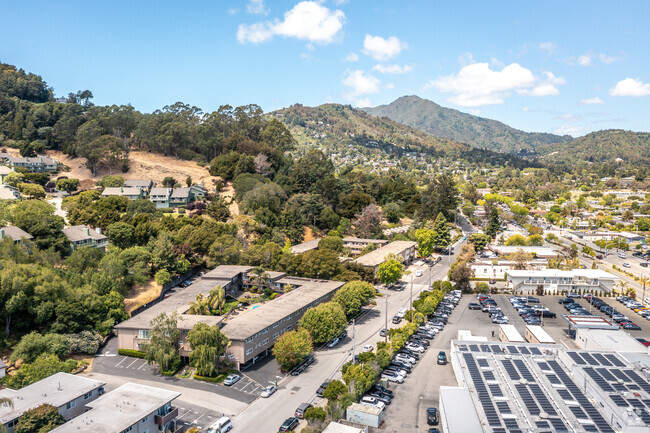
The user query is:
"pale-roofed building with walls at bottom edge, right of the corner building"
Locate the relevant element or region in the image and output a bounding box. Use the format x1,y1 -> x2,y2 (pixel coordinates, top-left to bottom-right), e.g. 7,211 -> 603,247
51,382 -> 185,433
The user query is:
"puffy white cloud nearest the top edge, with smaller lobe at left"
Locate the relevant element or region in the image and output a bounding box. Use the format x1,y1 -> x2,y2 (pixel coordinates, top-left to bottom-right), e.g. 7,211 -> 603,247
237,1 -> 346,44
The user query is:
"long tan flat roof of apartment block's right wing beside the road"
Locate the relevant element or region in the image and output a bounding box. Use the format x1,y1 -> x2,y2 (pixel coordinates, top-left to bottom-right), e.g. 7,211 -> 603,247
221,279 -> 345,340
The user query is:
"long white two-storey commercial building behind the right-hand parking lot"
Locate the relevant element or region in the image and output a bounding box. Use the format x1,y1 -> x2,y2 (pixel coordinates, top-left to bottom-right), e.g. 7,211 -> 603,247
506,269 -> 618,295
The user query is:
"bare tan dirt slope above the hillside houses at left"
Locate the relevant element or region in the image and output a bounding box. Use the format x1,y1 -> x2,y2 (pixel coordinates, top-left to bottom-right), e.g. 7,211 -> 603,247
47,150 -> 221,191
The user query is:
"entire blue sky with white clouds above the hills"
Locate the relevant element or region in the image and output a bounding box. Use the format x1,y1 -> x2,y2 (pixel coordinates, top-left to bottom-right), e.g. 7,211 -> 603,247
0,0 -> 650,136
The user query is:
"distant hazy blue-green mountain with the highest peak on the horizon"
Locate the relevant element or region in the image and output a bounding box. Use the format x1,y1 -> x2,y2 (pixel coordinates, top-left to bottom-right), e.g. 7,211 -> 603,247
363,96 -> 572,153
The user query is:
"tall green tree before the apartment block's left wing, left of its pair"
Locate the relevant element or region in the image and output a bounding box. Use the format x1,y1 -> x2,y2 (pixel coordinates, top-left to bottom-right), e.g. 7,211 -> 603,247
144,312 -> 181,372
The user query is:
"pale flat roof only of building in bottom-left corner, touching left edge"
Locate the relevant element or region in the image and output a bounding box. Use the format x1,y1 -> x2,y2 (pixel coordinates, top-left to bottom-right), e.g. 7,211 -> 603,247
0,373 -> 106,424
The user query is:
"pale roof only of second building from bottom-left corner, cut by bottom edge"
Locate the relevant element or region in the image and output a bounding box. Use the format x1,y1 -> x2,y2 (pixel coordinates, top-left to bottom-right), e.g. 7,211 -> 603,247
52,382 -> 181,433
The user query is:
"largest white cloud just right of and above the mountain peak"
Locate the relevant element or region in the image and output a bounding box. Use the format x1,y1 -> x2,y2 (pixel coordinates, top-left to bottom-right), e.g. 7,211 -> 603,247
425,63 -> 535,107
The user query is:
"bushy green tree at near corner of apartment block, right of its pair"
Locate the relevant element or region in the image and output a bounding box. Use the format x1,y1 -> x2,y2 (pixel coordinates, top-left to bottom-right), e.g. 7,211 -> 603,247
187,323 -> 230,377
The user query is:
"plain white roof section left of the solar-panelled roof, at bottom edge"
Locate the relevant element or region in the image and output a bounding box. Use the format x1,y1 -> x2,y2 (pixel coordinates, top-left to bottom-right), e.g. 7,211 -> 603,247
439,386 -> 483,433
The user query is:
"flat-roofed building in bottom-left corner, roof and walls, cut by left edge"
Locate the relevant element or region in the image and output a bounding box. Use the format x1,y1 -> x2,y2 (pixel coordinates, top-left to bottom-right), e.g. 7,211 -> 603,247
0,373 -> 106,433
